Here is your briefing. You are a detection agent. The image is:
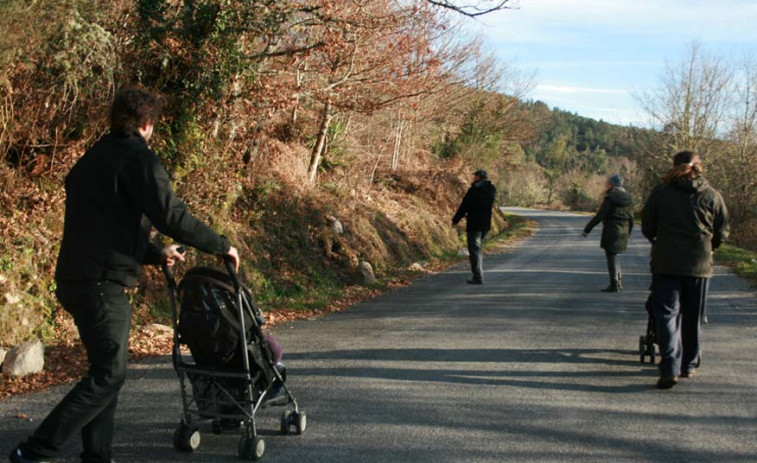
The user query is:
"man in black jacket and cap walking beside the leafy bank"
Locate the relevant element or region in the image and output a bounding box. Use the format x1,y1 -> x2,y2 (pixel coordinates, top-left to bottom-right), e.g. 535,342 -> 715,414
452,170 -> 497,285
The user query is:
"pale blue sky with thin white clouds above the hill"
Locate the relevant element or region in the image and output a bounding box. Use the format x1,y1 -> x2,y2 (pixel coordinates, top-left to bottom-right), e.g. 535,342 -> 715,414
468,0 -> 757,126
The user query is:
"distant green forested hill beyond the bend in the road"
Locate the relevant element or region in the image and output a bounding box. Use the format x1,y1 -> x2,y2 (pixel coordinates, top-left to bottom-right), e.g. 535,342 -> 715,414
499,101 -> 653,214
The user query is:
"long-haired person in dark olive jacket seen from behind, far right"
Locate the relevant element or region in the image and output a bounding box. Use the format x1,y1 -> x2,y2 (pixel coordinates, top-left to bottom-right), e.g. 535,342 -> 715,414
641,151 -> 729,389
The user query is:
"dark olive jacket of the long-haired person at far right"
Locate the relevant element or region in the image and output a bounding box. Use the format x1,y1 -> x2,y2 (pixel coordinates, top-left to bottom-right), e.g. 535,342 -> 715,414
641,177 -> 729,278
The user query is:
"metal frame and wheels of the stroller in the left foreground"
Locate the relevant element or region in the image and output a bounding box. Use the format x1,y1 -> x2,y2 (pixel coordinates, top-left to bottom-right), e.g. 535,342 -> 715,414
163,258 -> 307,461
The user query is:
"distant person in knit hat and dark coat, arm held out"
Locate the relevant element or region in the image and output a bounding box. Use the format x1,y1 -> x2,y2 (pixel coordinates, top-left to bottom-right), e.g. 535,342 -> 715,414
581,174 -> 633,293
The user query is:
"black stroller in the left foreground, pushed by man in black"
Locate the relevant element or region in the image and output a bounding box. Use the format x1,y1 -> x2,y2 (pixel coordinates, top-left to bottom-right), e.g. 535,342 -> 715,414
163,259 -> 307,461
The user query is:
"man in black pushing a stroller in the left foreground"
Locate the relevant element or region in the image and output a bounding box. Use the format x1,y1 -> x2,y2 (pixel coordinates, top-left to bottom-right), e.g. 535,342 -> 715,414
9,88 -> 239,463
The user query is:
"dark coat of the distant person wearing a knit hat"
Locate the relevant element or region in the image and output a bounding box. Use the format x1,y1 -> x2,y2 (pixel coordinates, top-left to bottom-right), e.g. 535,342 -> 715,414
584,187 -> 633,254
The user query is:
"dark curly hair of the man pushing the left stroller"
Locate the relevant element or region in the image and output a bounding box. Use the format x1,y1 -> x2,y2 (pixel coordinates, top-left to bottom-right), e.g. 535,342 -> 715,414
110,87 -> 161,135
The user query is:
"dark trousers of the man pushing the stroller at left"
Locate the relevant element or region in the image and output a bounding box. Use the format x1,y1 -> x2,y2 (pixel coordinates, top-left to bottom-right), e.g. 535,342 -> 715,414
21,282 -> 131,463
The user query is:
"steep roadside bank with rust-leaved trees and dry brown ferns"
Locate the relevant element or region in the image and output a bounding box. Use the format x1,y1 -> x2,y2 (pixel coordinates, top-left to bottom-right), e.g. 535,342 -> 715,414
0,0 -> 524,346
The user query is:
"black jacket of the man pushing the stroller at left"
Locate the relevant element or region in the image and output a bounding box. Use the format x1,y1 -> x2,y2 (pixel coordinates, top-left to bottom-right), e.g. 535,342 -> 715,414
55,134 -> 229,286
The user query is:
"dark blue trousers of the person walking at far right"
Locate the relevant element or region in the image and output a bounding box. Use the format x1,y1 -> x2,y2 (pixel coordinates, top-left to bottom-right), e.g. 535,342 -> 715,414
650,275 -> 707,376
